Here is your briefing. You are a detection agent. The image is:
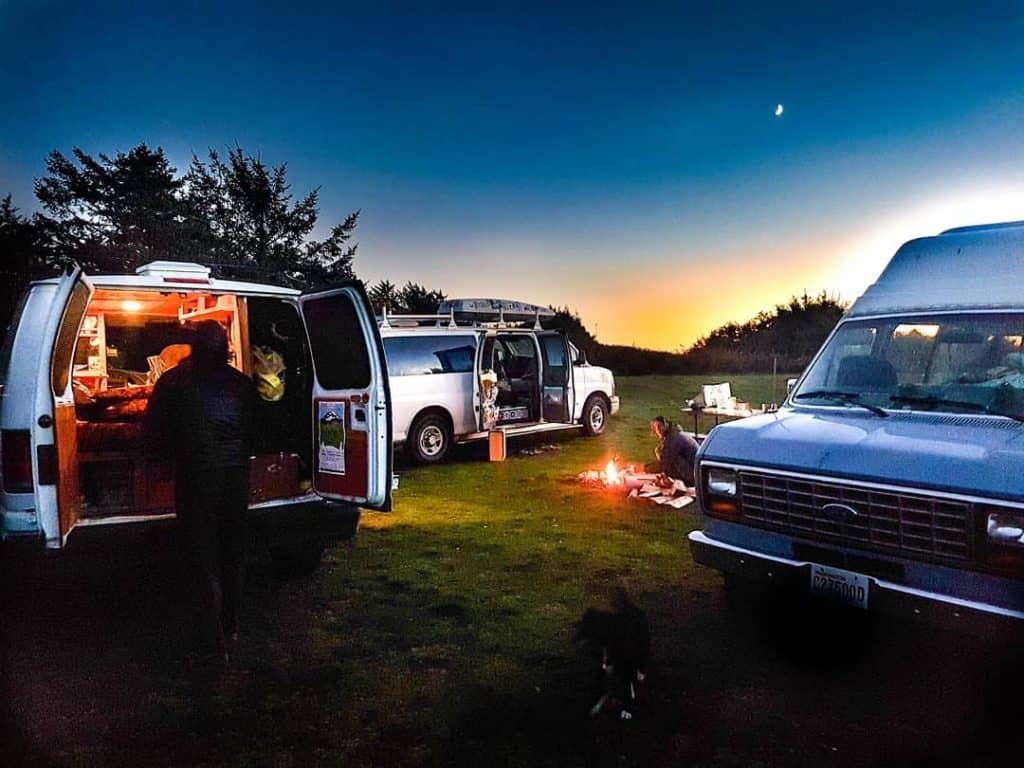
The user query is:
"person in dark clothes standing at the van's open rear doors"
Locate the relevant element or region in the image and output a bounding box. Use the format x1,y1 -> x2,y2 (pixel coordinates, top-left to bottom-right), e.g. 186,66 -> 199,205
145,321 -> 256,659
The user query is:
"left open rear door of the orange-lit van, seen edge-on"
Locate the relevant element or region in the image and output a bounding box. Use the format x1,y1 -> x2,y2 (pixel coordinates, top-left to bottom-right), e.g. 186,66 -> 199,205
39,266 -> 93,547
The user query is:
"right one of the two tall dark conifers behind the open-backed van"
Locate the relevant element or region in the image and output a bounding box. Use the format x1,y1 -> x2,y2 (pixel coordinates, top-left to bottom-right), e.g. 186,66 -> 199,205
183,147 -> 359,288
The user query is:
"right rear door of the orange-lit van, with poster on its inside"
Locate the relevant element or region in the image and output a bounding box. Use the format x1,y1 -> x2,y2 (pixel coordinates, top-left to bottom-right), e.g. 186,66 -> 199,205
299,281 -> 392,510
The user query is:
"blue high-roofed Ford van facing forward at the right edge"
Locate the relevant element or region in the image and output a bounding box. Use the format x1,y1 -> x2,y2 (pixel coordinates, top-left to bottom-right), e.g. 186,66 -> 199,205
689,222 -> 1024,628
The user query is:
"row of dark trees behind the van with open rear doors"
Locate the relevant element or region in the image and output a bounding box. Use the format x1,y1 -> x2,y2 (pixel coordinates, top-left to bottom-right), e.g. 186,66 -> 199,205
0,143 -> 444,322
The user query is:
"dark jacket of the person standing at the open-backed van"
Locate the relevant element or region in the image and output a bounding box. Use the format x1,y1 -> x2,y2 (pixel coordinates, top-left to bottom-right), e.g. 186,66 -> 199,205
145,358 -> 256,473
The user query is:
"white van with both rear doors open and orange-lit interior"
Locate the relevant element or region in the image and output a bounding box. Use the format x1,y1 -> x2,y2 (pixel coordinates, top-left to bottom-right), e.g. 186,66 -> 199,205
0,262 -> 392,556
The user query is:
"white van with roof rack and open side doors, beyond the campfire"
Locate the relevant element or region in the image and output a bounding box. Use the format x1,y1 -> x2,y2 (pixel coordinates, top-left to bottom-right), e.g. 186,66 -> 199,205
379,299 -> 620,464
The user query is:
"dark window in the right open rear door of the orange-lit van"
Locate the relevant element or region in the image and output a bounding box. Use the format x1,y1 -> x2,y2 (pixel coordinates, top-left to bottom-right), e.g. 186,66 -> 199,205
302,294 -> 370,389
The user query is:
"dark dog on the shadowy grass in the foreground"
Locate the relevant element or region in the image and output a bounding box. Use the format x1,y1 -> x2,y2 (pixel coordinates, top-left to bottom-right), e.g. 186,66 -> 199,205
573,589 -> 650,720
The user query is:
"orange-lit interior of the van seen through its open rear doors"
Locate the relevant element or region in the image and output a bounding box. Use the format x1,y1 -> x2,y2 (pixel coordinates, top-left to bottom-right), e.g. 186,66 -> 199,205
73,289 -> 312,517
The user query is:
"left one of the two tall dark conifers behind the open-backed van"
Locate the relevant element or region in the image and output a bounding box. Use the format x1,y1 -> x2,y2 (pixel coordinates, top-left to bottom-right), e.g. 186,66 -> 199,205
35,143 -> 192,272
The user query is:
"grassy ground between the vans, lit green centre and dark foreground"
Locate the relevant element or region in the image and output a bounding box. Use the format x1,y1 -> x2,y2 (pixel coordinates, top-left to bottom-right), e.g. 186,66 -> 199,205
9,377 -> 1024,768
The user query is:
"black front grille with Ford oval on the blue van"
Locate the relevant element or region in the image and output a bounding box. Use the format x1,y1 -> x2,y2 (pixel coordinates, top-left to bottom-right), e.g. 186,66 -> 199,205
739,471 -> 971,560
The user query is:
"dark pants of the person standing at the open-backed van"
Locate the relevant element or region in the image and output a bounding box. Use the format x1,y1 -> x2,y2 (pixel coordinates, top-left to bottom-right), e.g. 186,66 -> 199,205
175,467 -> 249,652
